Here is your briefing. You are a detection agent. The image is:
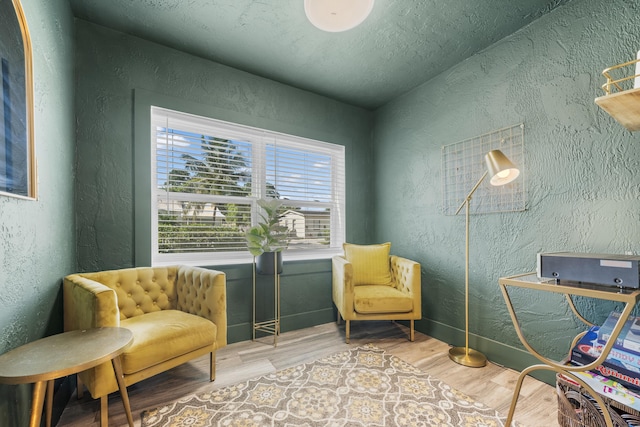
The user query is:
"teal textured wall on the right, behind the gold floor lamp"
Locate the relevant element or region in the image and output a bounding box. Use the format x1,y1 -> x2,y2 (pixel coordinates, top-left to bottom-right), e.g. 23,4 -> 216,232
374,0 -> 640,366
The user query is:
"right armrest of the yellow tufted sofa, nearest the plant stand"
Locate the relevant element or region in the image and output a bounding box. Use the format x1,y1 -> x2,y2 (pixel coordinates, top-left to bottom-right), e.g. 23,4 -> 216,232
176,265 -> 227,348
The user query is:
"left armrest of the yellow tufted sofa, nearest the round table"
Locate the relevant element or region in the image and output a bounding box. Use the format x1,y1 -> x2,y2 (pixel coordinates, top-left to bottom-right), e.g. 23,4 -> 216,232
62,274 -> 120,331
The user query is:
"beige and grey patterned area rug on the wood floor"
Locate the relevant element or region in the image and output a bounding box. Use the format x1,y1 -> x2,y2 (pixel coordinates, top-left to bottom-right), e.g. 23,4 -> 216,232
142,345 -> 506,427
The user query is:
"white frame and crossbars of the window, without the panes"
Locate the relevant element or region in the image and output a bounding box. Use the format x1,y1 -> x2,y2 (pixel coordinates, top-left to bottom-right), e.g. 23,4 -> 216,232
149,104 -> 346,265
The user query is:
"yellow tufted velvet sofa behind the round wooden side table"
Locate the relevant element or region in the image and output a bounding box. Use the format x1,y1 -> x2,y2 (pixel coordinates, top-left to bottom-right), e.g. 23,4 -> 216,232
63,266 -> 227,425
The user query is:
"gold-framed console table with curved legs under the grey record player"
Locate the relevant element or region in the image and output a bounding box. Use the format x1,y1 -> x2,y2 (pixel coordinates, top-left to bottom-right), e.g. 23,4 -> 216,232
498,273 -> 640,427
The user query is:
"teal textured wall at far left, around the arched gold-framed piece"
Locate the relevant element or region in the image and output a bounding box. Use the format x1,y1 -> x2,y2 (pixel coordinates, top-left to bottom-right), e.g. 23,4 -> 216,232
0,0 -> 76,426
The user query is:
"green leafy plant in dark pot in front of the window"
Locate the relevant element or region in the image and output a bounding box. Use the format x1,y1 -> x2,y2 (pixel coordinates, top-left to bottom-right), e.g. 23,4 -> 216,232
245,199 -> 290,274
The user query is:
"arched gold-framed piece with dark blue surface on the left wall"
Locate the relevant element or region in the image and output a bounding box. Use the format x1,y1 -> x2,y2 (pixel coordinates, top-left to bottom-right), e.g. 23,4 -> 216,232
0,0 -> 36,199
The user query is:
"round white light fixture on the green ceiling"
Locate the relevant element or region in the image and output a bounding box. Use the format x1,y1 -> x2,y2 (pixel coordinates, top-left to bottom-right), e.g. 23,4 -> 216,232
304,0 -> 374,33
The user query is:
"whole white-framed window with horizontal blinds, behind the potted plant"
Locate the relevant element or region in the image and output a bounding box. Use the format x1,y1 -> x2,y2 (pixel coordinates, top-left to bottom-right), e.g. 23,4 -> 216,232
151,107 -> 345,265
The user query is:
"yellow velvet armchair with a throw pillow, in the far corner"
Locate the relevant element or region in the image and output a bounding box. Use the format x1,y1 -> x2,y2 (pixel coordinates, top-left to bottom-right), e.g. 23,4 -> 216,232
332,243 -> 422,343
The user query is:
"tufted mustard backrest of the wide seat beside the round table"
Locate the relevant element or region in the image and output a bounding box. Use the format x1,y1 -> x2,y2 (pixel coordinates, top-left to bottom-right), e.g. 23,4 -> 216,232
79,266 -> 178,320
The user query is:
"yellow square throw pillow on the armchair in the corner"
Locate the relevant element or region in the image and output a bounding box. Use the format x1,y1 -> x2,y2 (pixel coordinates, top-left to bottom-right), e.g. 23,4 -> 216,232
342,242 -> 391,285
